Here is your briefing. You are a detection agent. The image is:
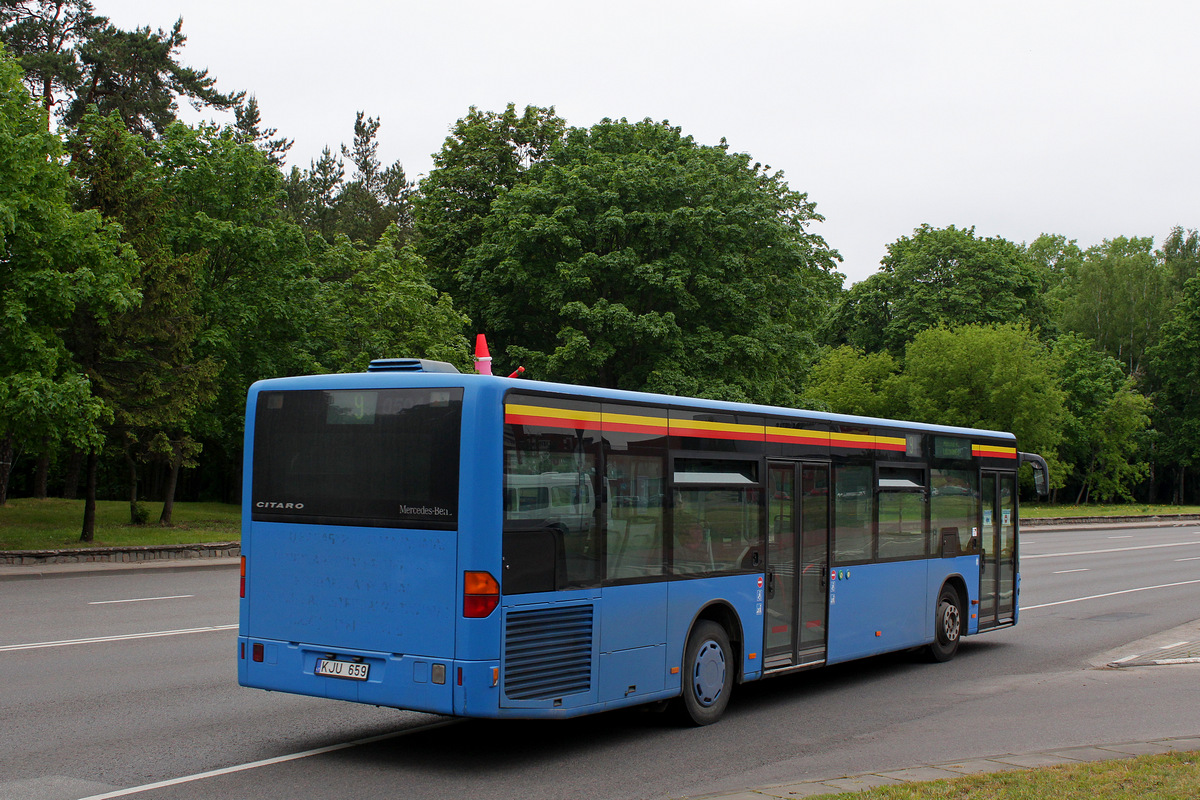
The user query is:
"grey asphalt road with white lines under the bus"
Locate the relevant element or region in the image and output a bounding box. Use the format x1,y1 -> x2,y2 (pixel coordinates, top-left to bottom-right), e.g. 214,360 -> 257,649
0,525 -> 1200,800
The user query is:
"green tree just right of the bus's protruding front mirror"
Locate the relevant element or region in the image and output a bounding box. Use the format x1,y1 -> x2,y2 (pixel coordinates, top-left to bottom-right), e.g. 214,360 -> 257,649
1054,333 -> 1151,503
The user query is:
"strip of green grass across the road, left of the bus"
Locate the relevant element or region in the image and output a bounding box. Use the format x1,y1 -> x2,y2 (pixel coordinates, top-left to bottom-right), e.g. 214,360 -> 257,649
0,498 -> 241,551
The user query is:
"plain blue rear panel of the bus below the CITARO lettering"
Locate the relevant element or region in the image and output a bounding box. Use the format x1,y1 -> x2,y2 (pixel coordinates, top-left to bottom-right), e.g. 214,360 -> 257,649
239,523 -> 457,714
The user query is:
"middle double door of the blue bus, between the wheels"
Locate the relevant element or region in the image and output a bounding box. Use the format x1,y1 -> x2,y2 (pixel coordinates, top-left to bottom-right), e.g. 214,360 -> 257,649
763,462 -> 829,670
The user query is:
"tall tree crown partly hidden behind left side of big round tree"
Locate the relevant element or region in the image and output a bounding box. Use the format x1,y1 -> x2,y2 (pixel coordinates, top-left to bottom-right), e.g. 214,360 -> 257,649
414,103 -> 566,290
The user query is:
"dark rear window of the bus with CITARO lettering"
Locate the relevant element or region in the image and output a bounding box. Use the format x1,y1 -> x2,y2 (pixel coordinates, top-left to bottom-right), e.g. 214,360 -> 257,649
251,389 -> 462,529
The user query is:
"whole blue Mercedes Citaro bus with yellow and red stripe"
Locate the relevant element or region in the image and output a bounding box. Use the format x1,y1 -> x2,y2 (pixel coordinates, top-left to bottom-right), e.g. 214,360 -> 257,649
238,359 -> 1045,724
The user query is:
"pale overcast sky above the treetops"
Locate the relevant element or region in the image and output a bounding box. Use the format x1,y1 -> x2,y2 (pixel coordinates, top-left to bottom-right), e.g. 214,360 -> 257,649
94,0 -> 1200,283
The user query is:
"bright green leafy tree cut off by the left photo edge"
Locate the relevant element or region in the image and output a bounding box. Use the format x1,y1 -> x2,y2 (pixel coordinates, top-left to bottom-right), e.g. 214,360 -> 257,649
0,45 -> 138,503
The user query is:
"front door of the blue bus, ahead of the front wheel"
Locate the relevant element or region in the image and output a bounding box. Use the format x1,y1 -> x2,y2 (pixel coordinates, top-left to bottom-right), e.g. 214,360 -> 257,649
979,471 -> 1018,631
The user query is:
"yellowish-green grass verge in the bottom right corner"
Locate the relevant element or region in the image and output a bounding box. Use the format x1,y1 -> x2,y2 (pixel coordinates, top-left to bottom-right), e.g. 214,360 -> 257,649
820,752 -> 1200,800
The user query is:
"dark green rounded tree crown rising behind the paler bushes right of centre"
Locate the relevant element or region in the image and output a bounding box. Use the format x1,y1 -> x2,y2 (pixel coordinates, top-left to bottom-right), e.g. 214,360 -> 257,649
827,224 -> 1049,355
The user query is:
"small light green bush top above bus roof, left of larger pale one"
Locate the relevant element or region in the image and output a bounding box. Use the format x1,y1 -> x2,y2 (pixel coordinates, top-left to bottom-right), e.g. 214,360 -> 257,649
800,345 -> 906,417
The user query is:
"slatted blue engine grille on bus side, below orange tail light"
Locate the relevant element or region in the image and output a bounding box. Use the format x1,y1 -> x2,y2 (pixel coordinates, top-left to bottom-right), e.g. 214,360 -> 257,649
504,606 -> 592,700
